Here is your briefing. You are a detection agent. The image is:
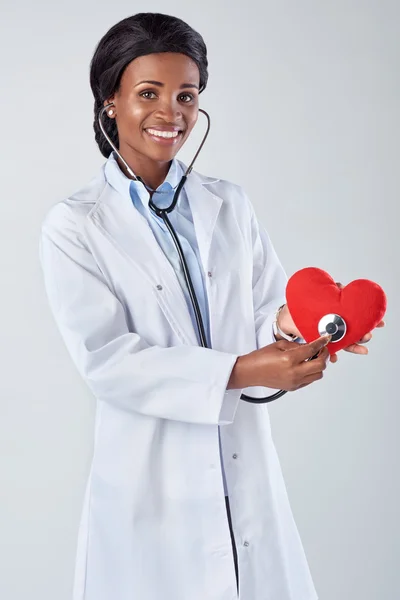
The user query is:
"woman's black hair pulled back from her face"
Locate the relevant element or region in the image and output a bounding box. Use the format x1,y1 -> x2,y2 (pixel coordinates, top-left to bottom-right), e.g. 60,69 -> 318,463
90,13 -> 208,158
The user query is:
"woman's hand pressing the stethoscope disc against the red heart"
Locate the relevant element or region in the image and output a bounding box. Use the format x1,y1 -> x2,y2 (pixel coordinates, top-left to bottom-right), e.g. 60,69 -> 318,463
227,336 -> 331,392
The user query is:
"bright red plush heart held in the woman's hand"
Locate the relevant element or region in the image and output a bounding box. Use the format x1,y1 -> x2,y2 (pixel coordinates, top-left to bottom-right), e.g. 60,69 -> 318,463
286,267 -> 387,354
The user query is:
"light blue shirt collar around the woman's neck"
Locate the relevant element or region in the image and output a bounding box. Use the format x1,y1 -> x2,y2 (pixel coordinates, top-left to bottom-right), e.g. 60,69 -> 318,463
105,152 -> 182,209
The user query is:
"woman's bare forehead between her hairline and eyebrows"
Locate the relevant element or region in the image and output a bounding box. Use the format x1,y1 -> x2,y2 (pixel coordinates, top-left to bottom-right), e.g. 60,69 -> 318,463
121,52 -> 200,86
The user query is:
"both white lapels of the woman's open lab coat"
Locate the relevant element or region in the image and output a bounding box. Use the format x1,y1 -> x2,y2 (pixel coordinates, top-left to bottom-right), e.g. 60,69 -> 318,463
88,163 -> 222,345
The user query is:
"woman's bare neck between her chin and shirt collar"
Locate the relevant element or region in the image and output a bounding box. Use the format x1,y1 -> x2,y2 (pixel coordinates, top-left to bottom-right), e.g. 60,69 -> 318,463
117,144 -> 172,189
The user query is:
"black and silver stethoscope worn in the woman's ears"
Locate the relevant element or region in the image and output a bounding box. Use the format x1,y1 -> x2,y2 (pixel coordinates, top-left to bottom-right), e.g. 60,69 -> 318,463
98,102 -> 346,404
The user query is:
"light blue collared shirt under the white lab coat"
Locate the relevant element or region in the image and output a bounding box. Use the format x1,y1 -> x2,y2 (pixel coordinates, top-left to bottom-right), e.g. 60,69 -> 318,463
105,152 -> 228,496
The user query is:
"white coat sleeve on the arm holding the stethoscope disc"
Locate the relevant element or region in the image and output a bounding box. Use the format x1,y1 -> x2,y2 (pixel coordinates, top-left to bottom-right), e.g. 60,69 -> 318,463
40,204 -> 241,424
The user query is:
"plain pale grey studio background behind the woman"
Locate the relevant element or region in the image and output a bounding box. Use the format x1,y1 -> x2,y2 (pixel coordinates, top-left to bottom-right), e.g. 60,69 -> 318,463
0,0 -> 400,600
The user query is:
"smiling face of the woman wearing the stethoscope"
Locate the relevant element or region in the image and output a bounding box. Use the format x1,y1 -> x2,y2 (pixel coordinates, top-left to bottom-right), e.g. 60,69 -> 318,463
104,52 -> 200,187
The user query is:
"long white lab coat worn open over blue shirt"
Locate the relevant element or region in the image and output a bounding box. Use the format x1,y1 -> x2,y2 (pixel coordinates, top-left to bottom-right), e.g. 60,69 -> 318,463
40,162 -> 317,600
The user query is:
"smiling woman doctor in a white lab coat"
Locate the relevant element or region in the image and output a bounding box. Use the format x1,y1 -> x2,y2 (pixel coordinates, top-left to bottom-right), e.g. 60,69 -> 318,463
40,13 -> 382,600
